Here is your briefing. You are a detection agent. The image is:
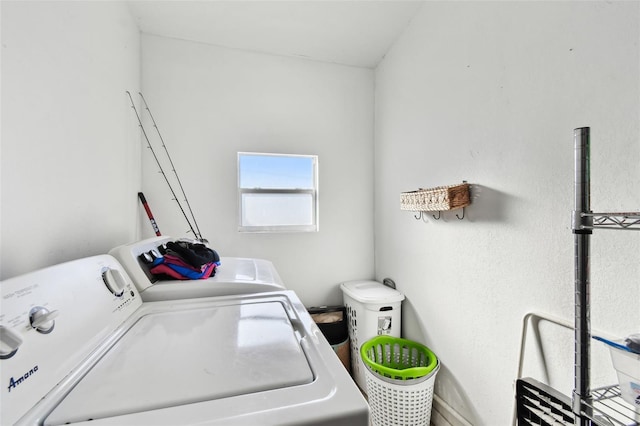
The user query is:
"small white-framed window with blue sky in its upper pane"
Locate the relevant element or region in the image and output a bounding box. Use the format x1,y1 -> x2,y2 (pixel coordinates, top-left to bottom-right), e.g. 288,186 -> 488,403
238,152 -> 318,232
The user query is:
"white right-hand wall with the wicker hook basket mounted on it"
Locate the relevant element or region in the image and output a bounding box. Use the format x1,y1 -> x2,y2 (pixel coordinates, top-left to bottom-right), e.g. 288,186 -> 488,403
375,2 -> 640,425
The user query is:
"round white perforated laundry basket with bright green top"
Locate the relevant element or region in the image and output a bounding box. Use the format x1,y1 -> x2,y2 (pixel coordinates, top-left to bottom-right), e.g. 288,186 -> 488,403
360,336 -> 440,426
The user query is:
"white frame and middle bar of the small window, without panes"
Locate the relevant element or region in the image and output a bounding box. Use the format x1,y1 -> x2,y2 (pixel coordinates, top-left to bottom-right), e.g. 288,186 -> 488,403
237,151 -> 320,233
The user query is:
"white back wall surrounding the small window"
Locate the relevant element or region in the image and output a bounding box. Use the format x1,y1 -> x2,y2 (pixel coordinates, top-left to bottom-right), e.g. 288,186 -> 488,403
137,35 -> 374,306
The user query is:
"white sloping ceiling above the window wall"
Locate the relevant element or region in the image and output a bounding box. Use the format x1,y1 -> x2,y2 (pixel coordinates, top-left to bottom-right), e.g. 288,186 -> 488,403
128,0 -> 423,68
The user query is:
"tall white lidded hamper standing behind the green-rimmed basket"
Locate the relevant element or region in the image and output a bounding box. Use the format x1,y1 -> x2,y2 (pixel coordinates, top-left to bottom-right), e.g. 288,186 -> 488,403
340,280 -> 404,393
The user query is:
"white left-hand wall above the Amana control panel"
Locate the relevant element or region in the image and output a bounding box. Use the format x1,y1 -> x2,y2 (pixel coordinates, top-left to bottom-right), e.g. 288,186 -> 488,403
0,1 -> 140,279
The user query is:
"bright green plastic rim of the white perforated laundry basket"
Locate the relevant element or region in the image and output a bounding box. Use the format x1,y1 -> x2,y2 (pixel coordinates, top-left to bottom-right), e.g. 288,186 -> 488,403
360,336 -> 438,380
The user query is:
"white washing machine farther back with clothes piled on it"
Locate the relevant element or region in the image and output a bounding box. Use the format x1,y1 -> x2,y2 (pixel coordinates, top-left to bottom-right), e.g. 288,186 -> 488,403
109,236 -> 285,302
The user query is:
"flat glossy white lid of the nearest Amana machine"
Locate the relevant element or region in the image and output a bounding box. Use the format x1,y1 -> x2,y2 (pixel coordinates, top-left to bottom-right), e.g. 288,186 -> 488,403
45,301 -> 314,424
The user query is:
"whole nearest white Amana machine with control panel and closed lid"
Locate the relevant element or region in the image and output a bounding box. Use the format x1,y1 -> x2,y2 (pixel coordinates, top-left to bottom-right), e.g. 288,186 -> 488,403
0,255 -> 368,426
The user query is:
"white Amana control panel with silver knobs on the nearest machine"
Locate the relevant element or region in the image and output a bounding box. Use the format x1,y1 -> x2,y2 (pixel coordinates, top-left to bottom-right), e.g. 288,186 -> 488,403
0,255 -> 142,424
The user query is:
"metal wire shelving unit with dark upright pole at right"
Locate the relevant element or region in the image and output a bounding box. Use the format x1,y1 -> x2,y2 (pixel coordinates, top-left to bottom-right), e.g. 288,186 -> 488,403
516,127 -> 640,426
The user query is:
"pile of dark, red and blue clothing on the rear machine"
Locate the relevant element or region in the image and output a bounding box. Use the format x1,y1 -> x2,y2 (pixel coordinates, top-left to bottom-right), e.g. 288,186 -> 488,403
149,241 -> 220,280
